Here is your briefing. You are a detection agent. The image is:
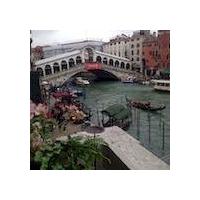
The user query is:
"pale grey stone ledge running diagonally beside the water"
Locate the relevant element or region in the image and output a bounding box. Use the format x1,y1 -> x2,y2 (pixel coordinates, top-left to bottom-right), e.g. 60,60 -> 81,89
71,126 -> 170,170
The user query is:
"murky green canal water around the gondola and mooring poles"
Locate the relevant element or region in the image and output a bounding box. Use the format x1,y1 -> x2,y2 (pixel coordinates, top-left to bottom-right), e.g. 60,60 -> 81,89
80,81 -> 170,163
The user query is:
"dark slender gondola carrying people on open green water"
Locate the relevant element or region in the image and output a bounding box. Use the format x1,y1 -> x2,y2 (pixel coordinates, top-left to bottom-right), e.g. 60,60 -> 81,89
126,98 -> 166,112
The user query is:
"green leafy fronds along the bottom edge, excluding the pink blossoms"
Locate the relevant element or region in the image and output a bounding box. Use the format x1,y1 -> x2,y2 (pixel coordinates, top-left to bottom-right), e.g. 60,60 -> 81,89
34,137 -> 108,170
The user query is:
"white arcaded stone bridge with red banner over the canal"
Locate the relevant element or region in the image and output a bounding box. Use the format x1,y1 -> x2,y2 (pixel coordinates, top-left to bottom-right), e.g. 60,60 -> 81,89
35,47 -> 141,84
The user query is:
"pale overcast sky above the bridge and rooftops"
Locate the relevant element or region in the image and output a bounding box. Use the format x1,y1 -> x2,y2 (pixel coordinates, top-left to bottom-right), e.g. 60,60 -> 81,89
32,29 -> 156,47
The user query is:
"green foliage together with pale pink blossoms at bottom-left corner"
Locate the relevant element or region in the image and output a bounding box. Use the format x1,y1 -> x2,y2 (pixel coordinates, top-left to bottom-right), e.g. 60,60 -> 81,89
30,115 -> 109,170
